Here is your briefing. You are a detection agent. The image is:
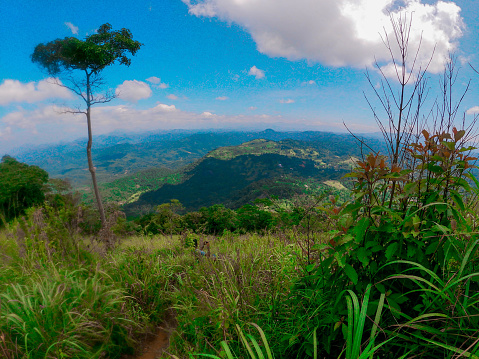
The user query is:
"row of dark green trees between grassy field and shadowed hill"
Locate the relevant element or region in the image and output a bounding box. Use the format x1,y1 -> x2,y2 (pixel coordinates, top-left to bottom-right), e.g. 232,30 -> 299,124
134,195 -> 325,235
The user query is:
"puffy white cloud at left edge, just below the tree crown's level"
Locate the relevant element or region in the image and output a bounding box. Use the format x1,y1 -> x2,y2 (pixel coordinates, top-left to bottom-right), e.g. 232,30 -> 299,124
0,78 -> 73,106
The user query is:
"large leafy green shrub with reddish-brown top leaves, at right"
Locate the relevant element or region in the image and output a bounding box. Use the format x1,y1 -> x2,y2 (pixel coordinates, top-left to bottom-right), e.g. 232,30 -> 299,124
286,128 -> 477,357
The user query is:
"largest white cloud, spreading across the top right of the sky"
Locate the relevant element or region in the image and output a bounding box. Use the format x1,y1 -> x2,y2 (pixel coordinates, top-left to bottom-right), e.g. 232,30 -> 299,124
187,0 -> 464,73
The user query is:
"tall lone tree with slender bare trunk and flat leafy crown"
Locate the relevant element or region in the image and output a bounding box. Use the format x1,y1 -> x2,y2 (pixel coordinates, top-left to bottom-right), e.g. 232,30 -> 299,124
31,23 -> 142,227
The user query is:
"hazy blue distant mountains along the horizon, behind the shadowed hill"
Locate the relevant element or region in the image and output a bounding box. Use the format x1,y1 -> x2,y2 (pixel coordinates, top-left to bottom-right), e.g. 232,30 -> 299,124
14,130 -> 380,187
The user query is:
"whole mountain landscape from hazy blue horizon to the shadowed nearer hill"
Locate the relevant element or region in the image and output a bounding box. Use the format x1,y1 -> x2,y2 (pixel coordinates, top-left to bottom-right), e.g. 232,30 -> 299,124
11,130 -> 384,216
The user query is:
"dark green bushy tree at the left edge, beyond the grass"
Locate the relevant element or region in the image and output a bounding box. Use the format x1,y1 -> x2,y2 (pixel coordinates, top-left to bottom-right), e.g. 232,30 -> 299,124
0,156 -> 48,221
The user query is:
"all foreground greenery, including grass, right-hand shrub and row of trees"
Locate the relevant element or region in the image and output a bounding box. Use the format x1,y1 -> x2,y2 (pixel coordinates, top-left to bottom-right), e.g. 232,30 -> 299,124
0,124 -> 479,359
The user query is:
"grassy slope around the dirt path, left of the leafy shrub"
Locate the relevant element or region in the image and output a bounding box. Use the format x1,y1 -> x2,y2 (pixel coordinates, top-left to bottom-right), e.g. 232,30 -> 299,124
0,232 -> 297,359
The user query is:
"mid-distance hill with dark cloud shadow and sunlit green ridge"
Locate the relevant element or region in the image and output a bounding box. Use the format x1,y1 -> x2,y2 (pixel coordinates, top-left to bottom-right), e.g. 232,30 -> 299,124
124,139 -> 354,215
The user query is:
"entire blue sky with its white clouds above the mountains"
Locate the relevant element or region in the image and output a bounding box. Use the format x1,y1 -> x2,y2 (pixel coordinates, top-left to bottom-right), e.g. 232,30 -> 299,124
0,0 -> 479,154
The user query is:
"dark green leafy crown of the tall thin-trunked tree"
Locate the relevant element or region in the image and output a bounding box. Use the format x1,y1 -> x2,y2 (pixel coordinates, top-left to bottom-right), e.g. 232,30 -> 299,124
31,23 -> 142,75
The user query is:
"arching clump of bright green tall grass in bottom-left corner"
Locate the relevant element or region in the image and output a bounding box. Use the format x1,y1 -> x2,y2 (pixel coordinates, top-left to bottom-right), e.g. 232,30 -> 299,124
0,269 -> 139,358
